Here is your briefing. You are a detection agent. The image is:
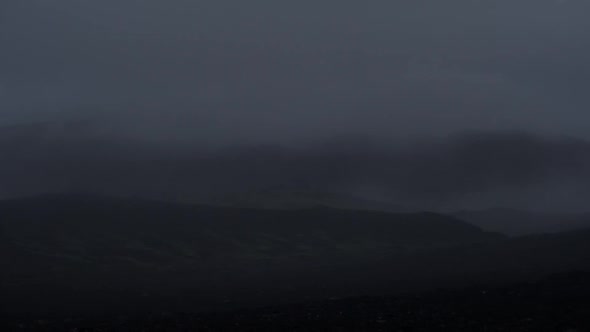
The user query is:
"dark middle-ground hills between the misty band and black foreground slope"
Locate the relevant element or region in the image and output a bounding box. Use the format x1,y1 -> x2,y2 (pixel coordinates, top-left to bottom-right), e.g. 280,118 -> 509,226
0,195 -> 590,310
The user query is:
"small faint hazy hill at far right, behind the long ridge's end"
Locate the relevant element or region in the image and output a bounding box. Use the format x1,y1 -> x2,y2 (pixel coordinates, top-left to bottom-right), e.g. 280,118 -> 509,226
452,208 -> 590,235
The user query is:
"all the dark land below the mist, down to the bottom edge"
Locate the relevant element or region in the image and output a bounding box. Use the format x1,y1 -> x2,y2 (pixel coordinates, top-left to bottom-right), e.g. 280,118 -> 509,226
0,195 -> 590,331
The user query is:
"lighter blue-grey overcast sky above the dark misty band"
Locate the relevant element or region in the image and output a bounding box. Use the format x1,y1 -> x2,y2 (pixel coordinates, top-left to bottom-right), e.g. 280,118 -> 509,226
0,0 -> 590,144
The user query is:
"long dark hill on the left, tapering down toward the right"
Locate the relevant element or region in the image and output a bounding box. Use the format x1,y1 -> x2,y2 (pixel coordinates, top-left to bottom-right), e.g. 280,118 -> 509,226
0,195 -> 502,296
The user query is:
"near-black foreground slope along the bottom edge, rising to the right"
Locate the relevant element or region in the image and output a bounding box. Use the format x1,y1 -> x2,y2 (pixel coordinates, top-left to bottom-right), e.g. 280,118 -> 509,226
1,272 -> 590,332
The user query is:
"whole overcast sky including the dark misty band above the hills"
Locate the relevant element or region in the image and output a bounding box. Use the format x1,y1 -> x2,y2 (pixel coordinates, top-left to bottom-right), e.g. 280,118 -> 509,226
0,0 -> 590,209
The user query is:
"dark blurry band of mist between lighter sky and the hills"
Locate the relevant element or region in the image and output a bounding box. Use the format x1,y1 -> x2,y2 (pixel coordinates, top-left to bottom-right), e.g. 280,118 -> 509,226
0,122 -> 590,210
